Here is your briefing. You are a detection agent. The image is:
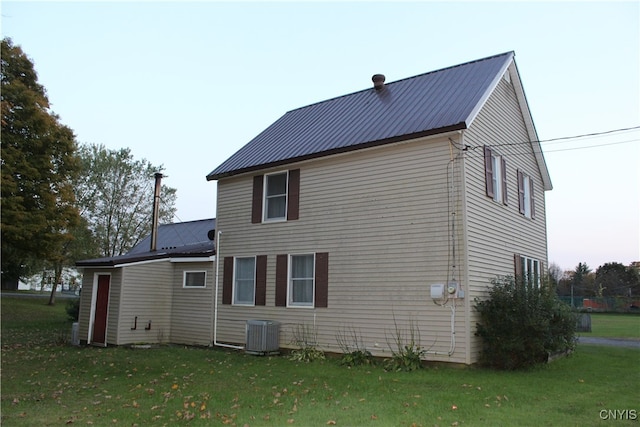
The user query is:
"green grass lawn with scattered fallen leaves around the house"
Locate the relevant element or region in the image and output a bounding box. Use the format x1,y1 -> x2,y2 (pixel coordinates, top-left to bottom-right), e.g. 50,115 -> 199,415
1,298 -> 640,426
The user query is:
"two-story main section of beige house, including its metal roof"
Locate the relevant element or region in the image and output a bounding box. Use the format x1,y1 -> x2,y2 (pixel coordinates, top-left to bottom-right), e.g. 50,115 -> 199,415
208,52 -> 552,364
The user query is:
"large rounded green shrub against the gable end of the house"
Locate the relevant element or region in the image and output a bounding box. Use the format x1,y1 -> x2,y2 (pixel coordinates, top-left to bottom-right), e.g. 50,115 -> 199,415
475,277 -> 576,370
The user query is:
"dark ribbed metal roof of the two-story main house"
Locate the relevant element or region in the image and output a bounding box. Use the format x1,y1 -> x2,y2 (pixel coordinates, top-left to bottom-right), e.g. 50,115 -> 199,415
207,52 -> 514,180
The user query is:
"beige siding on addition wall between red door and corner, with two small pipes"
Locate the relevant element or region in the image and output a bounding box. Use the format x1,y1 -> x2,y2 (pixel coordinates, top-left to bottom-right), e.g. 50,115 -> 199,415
116,260 -> 173,345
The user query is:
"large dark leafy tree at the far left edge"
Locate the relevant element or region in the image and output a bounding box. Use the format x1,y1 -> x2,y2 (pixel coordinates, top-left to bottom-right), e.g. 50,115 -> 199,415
0,38 -> 79,290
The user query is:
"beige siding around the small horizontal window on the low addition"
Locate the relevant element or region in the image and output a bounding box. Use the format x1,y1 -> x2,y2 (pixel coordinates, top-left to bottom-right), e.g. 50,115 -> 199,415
170,262 -> 215,345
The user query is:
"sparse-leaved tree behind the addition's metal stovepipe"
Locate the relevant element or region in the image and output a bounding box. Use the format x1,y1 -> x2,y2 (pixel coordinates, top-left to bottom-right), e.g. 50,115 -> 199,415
76,145 -> 176,257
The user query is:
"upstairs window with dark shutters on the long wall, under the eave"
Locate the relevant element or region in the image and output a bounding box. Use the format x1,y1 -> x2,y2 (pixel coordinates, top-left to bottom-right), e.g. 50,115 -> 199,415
251,169 -> 300,224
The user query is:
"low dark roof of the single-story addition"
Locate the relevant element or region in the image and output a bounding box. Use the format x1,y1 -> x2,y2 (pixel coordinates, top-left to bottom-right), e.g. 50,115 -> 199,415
76,219 -> 216,267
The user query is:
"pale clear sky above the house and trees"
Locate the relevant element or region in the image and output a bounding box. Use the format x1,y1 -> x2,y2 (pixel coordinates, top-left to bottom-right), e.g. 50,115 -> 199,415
0,1 -> 640,271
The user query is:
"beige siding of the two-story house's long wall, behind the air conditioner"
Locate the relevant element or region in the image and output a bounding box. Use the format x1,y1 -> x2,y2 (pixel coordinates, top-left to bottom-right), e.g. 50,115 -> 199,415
217,138 -> 466,362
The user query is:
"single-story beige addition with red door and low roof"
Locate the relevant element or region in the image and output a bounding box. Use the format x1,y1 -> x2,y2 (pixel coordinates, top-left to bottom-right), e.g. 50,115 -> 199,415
76,219 -> 216,346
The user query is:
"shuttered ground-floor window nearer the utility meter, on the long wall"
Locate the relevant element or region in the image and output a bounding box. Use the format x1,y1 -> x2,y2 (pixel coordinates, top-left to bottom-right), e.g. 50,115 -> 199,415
275,252 -> 329,308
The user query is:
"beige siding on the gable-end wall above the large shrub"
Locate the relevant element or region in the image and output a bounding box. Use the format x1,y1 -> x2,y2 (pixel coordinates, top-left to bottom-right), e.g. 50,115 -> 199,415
464,73 -> 547,359
